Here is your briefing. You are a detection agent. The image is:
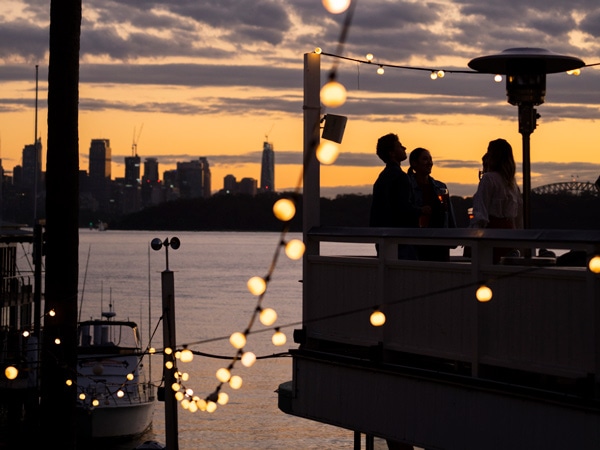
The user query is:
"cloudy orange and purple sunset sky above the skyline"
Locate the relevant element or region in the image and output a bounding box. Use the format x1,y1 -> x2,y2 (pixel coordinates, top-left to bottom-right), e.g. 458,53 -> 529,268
0,0 -> 600,196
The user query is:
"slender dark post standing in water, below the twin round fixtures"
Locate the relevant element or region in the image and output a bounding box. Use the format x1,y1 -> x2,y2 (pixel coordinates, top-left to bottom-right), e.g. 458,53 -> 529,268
161,263 -> 179,450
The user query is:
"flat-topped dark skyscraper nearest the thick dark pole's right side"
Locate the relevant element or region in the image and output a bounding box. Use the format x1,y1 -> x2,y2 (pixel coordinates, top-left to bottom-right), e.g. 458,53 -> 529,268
88,139 -> 112,212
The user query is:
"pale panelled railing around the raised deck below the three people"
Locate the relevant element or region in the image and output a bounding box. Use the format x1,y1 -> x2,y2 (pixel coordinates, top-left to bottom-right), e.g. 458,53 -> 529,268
303,227 -> 600,380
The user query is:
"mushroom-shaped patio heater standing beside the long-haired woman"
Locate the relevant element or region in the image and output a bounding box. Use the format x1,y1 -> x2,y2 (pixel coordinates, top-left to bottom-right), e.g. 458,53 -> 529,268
469,47 -> 585,228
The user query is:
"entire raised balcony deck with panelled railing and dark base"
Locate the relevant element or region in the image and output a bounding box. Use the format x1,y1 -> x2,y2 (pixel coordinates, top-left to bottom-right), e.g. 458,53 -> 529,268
280,227 -> 600,449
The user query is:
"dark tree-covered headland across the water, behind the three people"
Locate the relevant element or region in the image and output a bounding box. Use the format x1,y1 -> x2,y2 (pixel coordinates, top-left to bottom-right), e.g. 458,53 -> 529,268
108,192 -> 600,232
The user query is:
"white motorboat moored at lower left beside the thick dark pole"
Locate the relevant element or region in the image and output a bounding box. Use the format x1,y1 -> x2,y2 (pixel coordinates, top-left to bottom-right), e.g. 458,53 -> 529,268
77,307 -> 156,439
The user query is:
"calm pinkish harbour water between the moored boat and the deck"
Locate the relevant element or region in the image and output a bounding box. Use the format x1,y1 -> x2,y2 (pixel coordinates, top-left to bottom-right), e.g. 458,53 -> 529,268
71,230 -> 386,450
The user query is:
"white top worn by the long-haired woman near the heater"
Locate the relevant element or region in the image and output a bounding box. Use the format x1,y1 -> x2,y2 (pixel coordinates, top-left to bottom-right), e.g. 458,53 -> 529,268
470,172 -> 523,228
